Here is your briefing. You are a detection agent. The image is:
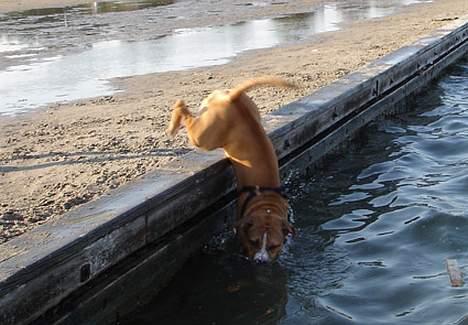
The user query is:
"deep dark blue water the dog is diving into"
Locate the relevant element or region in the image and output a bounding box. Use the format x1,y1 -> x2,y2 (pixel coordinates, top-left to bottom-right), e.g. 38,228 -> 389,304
121,57 -> 468,325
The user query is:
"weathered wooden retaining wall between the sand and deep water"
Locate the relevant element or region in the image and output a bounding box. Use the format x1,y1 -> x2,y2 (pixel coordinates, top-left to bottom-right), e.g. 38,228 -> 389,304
0,19 -> 468,324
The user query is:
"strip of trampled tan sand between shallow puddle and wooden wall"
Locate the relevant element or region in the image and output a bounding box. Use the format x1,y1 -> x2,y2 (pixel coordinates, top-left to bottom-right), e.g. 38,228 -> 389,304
0,0 -> 468,243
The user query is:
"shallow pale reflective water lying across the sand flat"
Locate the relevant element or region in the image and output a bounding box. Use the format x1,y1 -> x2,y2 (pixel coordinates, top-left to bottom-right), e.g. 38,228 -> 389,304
0,0 -> 427,114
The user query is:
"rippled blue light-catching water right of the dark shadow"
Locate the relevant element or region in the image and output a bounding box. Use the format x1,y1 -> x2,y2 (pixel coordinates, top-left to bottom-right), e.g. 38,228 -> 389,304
286,59 -> 468,324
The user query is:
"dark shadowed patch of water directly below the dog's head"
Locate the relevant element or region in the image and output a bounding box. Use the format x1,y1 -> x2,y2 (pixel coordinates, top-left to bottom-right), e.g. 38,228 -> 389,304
126,256 -> 288,324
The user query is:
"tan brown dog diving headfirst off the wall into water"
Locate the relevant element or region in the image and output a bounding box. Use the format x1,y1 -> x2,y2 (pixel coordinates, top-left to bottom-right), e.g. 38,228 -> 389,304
167,78 -> 293,262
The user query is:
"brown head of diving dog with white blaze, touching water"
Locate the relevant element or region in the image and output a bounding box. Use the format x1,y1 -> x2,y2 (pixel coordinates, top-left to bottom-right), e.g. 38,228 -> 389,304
236,194 -> 294,262
